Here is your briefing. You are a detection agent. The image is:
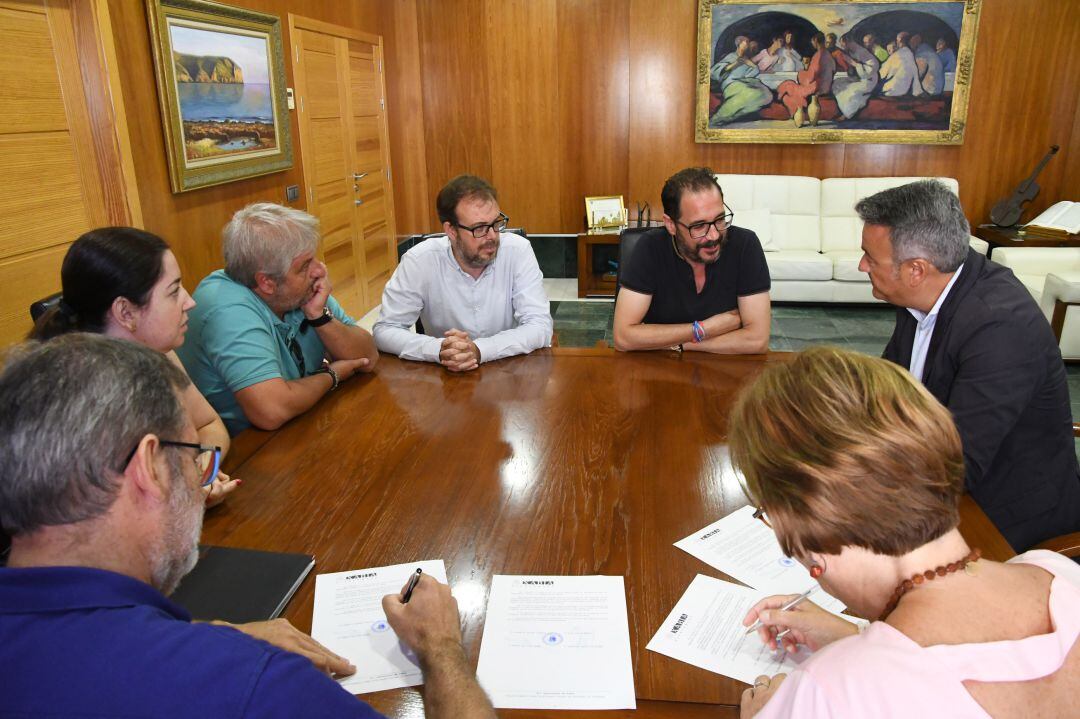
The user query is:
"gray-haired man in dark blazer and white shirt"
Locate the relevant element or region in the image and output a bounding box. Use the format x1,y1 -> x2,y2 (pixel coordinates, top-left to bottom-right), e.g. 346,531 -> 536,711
855,180 -> 1080,552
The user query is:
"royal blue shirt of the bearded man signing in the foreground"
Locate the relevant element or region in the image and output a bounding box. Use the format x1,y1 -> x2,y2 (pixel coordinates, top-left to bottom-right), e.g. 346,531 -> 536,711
0,567 -> 381,719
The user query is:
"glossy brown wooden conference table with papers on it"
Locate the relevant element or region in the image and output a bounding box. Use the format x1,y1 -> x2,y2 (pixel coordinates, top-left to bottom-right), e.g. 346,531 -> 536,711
203,348 -> 1012,718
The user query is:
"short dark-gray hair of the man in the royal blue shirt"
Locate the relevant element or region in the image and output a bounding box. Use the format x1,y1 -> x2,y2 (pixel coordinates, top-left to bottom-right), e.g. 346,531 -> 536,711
0,333 -> 191,535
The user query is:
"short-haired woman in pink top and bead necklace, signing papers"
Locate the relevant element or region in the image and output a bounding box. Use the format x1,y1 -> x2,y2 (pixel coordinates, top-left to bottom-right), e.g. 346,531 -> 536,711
729,348 -> 1080,719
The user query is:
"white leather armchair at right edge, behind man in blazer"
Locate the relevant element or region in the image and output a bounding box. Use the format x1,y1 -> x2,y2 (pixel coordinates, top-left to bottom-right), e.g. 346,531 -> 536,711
991,247 -> 1080,360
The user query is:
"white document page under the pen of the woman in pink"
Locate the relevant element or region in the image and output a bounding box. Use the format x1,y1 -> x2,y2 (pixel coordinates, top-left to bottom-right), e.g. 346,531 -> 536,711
647,574 -> 810,683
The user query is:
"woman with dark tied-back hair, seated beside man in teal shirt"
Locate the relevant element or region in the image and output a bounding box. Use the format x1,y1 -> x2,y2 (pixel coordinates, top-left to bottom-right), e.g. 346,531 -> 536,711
30,227 -> 241,506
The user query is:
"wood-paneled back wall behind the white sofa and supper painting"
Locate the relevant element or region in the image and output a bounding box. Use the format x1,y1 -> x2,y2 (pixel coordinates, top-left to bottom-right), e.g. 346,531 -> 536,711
388,0 -> 1080,232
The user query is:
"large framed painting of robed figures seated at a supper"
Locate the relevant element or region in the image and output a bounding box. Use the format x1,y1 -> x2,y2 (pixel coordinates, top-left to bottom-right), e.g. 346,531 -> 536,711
694,0 -> 982,145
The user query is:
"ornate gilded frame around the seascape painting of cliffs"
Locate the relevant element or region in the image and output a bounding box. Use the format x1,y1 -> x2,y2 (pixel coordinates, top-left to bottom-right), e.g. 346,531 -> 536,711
146,0 -> 293,192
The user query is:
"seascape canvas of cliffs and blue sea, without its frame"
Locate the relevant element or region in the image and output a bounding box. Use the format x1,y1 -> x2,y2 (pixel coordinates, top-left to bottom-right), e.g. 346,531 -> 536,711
170,23 -> 278,163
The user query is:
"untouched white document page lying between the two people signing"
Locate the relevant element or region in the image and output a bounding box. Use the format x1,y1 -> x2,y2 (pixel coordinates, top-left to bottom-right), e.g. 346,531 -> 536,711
476,575 -> 637,709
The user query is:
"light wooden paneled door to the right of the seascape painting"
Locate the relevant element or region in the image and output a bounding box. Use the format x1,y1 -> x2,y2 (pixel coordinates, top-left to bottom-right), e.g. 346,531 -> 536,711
289,15 -> 397,317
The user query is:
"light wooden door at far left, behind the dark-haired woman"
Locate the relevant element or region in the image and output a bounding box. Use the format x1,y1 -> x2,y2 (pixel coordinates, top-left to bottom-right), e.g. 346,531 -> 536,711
0,0 -> 139,348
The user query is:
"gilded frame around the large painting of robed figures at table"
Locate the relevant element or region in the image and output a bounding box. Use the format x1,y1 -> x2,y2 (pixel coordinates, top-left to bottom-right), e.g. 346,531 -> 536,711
694,0 -> 982,145
